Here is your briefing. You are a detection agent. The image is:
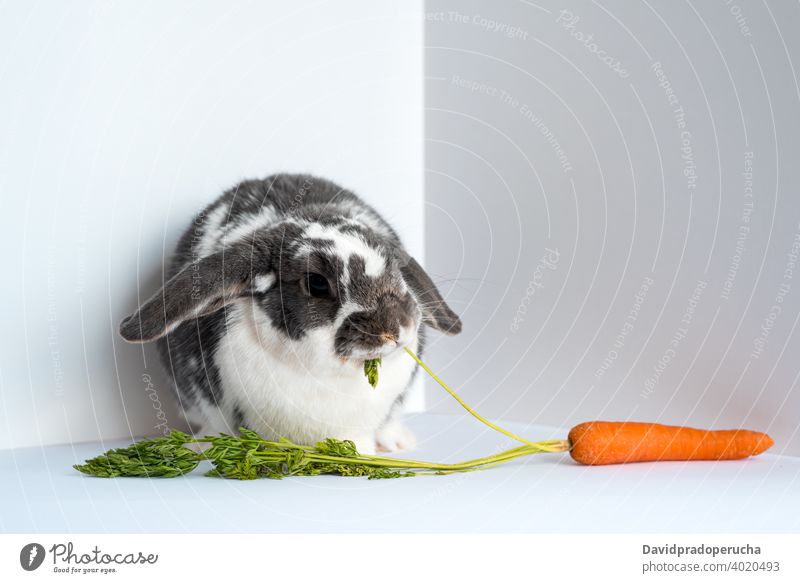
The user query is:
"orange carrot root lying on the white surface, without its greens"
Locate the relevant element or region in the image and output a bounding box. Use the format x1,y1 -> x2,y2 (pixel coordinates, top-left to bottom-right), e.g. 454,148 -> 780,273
569,421 -> 774,466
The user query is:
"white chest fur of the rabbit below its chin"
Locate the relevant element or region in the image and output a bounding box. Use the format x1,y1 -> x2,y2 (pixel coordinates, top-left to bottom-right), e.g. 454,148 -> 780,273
214,301 -> 416,452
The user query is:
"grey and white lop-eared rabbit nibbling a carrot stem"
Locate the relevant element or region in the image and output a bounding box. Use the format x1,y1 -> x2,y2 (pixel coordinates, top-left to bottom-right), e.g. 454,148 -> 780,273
115,174 -> 462,454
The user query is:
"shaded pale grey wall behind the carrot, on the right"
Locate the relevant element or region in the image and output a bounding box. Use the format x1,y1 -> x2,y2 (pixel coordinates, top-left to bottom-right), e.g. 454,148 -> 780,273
426,0 -> 800,455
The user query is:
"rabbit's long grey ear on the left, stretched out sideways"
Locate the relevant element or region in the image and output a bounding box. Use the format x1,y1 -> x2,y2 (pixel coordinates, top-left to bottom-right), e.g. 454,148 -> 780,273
119,242 -> 272,342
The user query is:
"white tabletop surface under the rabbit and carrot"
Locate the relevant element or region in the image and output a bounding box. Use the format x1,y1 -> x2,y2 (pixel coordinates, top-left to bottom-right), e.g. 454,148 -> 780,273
0,414 -> 800,533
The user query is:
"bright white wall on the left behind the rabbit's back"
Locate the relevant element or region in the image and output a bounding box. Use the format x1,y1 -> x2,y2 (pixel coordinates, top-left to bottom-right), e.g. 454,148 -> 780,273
0,0 -> 423,447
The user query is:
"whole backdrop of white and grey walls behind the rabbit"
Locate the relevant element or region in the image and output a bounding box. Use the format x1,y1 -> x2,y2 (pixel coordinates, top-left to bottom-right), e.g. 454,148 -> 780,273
0,0 -> 800,454
